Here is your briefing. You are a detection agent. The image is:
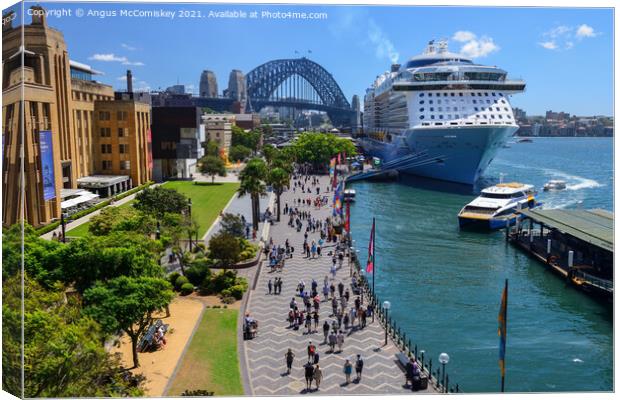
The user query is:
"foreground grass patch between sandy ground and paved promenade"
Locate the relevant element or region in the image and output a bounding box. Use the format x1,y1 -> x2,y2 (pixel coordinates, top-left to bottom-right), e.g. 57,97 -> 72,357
165,308 -> 243,396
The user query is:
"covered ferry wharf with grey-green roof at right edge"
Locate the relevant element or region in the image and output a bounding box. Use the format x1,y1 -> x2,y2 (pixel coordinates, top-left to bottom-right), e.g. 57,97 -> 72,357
506,209 -> 614,301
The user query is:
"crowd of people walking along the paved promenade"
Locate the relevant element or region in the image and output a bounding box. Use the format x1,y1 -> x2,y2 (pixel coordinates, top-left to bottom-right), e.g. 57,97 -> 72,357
254,167 -> 420,391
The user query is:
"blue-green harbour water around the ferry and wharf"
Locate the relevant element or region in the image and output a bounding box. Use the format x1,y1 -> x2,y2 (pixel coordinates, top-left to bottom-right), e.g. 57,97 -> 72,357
351,138 -> 613,393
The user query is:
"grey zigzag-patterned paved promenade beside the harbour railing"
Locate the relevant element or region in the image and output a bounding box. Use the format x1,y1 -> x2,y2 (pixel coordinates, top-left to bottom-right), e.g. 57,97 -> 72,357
239,177 -> 434,395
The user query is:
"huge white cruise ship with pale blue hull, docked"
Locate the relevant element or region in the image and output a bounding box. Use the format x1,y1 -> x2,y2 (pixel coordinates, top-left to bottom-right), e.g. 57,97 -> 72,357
359,41 -> 525,185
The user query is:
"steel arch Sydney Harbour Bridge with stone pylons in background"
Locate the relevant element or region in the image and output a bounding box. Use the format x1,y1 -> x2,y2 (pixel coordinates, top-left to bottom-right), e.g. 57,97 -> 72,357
191,57 -> 361,129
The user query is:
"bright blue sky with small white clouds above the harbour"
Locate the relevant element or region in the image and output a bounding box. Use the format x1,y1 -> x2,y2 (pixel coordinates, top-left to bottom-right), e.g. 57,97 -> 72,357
13,3 -> 613,115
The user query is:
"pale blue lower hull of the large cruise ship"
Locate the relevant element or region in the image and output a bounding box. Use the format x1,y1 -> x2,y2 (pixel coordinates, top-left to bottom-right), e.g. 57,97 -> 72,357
360,125 -> 518,185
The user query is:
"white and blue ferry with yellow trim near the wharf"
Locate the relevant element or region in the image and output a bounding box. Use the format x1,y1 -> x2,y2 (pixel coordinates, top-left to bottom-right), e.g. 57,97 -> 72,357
458,182 -> 541,230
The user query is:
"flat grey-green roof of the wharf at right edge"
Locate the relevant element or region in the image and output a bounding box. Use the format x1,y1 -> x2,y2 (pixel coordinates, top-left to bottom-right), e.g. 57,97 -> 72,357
520,209 -> 614,253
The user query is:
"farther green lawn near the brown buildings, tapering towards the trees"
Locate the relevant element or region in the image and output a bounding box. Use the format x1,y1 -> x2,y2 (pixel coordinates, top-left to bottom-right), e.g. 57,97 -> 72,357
165,181 -> 239,237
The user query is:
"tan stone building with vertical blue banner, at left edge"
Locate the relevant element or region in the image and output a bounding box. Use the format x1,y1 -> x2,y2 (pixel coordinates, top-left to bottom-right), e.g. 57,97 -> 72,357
2,6 -> 150,227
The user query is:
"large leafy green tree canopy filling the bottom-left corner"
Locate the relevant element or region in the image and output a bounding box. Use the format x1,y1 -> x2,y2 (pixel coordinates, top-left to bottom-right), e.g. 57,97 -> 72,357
2,275 -> 143,398
